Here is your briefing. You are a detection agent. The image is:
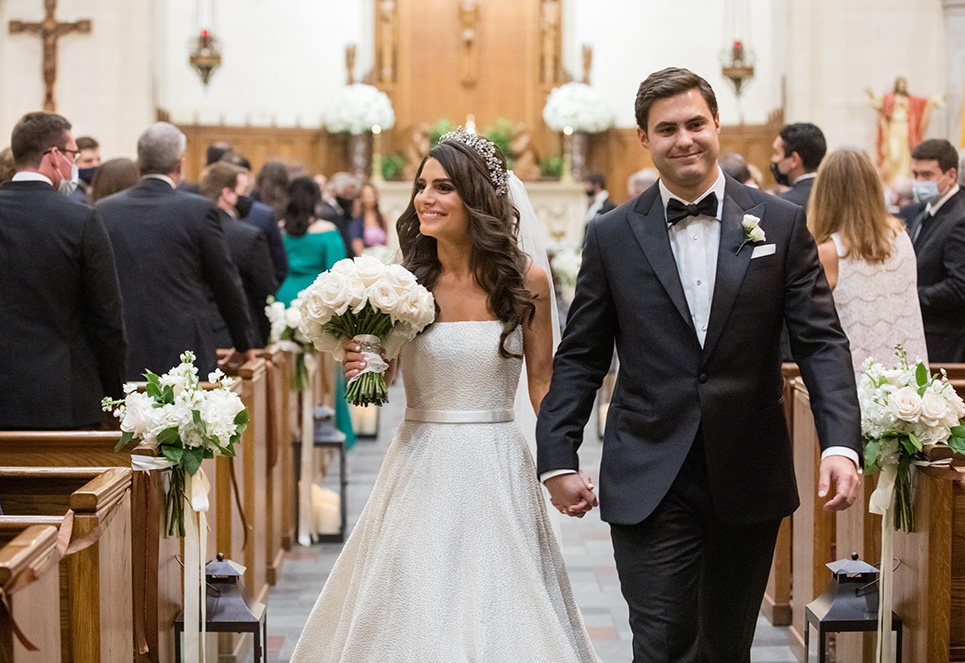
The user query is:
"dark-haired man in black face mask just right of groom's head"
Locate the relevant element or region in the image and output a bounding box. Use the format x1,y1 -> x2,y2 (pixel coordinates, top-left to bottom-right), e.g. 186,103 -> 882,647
771,122 -> 828,209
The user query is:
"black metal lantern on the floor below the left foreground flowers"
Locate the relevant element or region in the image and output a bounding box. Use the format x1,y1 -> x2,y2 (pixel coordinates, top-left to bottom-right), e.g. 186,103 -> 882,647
174,553 -> 268,663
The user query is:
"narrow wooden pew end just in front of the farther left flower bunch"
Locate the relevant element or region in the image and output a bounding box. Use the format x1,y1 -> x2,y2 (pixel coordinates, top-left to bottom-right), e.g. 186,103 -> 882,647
261,347 -> 295,585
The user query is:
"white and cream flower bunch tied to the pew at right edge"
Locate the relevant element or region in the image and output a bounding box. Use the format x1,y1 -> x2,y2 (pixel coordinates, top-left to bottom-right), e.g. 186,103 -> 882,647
858,345 -> 965,532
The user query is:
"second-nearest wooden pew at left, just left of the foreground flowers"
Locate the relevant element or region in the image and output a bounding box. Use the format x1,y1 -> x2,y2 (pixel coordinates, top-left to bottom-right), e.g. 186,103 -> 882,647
0,468 -> 134,662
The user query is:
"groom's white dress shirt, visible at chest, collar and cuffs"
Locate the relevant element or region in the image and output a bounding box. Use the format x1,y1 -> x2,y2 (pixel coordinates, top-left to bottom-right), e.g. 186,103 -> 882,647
539,166 -> 860,482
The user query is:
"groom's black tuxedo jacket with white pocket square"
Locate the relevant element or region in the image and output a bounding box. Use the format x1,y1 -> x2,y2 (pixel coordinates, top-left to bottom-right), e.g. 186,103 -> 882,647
537,177 -> 861,525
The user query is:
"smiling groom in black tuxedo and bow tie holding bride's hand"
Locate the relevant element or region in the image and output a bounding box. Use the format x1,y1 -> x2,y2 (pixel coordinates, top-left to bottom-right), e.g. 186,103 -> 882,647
537,68 -> 861,663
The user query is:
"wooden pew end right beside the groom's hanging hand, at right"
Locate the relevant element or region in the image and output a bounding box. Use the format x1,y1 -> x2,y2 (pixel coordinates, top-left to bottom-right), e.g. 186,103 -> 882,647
790,378 -> 835,660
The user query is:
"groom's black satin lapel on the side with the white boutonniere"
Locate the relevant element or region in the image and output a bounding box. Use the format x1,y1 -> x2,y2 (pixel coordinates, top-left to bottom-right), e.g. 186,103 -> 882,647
704,185 -> 767,359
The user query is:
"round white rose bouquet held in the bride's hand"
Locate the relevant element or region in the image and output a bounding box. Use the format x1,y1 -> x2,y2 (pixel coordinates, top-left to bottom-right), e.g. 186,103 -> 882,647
299,255 -> 436,405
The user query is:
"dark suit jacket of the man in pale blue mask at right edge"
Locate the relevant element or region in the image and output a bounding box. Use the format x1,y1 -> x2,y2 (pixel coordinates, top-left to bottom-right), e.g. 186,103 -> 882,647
900,190 -> 965,363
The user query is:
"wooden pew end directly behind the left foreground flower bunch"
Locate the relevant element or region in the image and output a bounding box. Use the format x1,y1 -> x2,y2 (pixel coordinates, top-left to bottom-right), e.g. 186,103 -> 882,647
215,358 -> 268,663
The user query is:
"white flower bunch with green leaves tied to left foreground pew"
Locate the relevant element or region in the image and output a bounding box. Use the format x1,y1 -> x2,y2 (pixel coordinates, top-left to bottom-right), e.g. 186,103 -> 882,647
101,351 -> 248,537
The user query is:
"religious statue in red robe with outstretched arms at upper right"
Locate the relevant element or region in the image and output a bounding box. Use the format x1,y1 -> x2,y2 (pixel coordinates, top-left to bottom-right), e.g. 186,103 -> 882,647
866,77 -> 944,185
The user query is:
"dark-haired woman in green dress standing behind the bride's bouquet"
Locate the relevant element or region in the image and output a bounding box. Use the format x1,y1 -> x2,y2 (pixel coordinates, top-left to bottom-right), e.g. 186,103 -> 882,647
277,177 -> 355,448
